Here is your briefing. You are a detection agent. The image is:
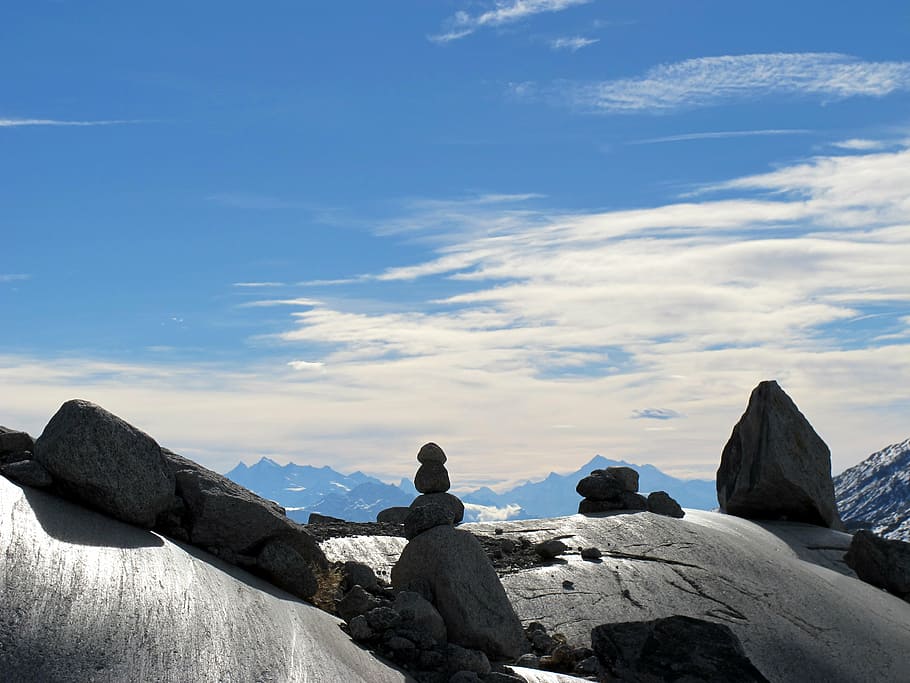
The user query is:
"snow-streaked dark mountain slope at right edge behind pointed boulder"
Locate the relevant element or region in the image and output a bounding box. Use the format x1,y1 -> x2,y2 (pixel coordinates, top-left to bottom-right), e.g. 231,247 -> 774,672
834,439 -> 910,541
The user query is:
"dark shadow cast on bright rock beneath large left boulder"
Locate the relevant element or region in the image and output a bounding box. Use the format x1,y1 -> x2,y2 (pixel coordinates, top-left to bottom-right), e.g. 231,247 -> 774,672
22,486 -> 164,548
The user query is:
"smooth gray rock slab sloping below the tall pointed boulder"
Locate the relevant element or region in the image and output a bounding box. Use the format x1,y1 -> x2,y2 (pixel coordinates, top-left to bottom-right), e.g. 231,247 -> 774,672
463,510 -> 910,683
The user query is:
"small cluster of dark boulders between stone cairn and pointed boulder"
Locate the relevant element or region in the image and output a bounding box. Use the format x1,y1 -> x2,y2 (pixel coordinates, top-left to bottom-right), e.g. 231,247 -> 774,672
575,467 -> 685,518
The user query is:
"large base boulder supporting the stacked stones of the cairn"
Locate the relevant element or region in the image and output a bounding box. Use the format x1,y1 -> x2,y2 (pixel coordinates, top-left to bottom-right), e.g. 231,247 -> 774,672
392,526 -> 525,659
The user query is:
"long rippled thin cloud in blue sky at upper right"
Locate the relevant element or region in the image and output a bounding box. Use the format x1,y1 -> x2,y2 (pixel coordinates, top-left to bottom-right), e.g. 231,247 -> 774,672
532,52 -> 910,114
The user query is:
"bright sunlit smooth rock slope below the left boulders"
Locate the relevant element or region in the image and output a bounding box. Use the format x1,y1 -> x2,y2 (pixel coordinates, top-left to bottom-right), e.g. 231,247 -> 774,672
0,478 -> 409,683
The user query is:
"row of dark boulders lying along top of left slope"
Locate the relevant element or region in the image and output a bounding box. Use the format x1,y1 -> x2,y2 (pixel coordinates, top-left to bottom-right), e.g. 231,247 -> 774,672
0,400 -> 328,598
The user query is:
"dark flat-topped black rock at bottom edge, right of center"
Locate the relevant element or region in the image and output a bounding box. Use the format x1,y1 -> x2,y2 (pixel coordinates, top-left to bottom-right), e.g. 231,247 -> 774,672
591,616 -> 767,683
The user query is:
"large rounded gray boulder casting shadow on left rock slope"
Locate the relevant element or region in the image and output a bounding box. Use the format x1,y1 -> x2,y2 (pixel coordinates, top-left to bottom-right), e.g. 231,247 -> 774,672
35,400 -> 174,528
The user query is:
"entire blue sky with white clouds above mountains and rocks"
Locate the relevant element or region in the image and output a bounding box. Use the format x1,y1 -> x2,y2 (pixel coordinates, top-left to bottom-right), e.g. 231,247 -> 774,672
0,0 -> 910,485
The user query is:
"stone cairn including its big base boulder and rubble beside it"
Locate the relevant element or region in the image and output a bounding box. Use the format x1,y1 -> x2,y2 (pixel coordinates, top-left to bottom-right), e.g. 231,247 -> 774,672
336,443 -> 530,683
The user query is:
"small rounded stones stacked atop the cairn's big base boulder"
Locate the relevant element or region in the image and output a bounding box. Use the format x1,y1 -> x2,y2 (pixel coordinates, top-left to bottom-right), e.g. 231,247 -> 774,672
405,443 -> 464,539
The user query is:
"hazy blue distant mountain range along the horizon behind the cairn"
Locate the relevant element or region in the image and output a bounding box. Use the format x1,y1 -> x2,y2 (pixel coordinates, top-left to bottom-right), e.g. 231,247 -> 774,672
226,455 -> 717,522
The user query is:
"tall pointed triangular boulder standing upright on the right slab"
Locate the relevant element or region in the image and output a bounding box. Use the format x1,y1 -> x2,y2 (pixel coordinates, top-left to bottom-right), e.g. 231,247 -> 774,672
717,381 -> 841,528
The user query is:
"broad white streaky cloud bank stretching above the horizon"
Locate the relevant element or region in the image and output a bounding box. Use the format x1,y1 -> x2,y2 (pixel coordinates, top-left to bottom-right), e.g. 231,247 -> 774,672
0,148 -> 910,487
